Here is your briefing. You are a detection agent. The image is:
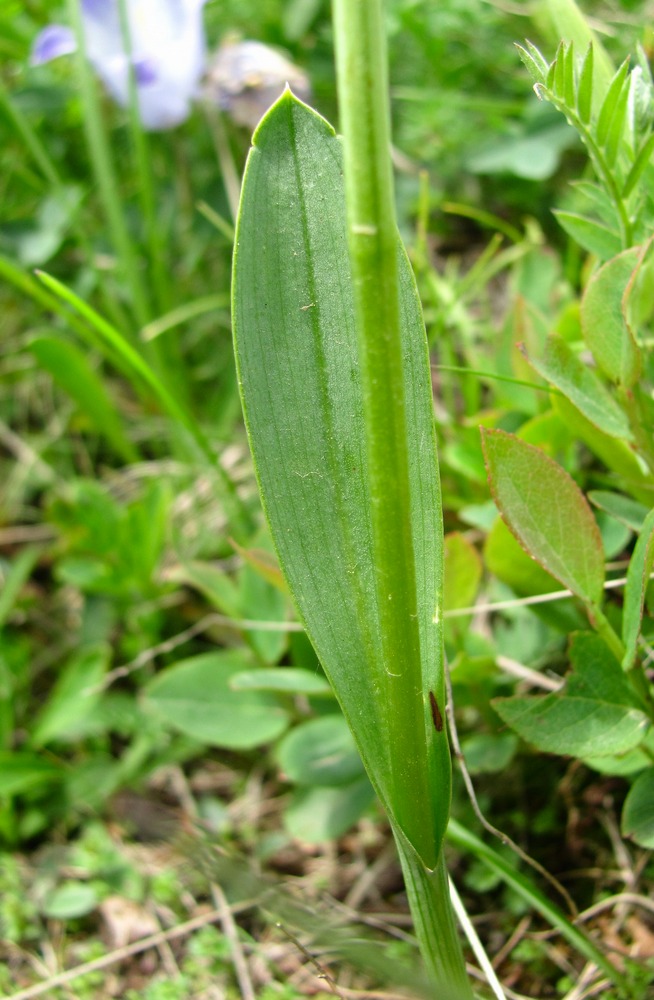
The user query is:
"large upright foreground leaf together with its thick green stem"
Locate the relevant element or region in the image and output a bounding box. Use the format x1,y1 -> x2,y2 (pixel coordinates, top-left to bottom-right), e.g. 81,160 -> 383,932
234,2 -> 472,998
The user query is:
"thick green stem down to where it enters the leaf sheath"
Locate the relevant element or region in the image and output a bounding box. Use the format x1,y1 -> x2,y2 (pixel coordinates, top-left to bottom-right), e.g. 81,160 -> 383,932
334,0 -> 430,864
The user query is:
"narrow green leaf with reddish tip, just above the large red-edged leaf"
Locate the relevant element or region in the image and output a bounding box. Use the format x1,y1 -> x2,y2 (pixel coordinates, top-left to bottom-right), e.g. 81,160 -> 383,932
529,336 -> 632,441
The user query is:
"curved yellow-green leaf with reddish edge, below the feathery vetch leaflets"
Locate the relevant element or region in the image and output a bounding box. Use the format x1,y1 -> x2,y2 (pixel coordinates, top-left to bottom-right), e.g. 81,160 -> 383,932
581,247 -> 642,388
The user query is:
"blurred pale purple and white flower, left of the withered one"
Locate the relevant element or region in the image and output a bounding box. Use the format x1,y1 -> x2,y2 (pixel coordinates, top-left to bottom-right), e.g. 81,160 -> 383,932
32,0 -> 206,130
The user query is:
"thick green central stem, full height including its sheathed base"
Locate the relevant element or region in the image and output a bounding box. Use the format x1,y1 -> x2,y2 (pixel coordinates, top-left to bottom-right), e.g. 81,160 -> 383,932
333,0 -> 473,1000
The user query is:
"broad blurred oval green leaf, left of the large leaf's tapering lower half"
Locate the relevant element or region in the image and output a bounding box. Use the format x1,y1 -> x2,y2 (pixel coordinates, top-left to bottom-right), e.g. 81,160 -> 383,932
144,650 -> 289,750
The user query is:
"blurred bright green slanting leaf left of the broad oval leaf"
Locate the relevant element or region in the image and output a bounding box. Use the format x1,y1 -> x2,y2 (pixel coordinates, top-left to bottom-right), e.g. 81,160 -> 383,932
30,644 -> 111,747
